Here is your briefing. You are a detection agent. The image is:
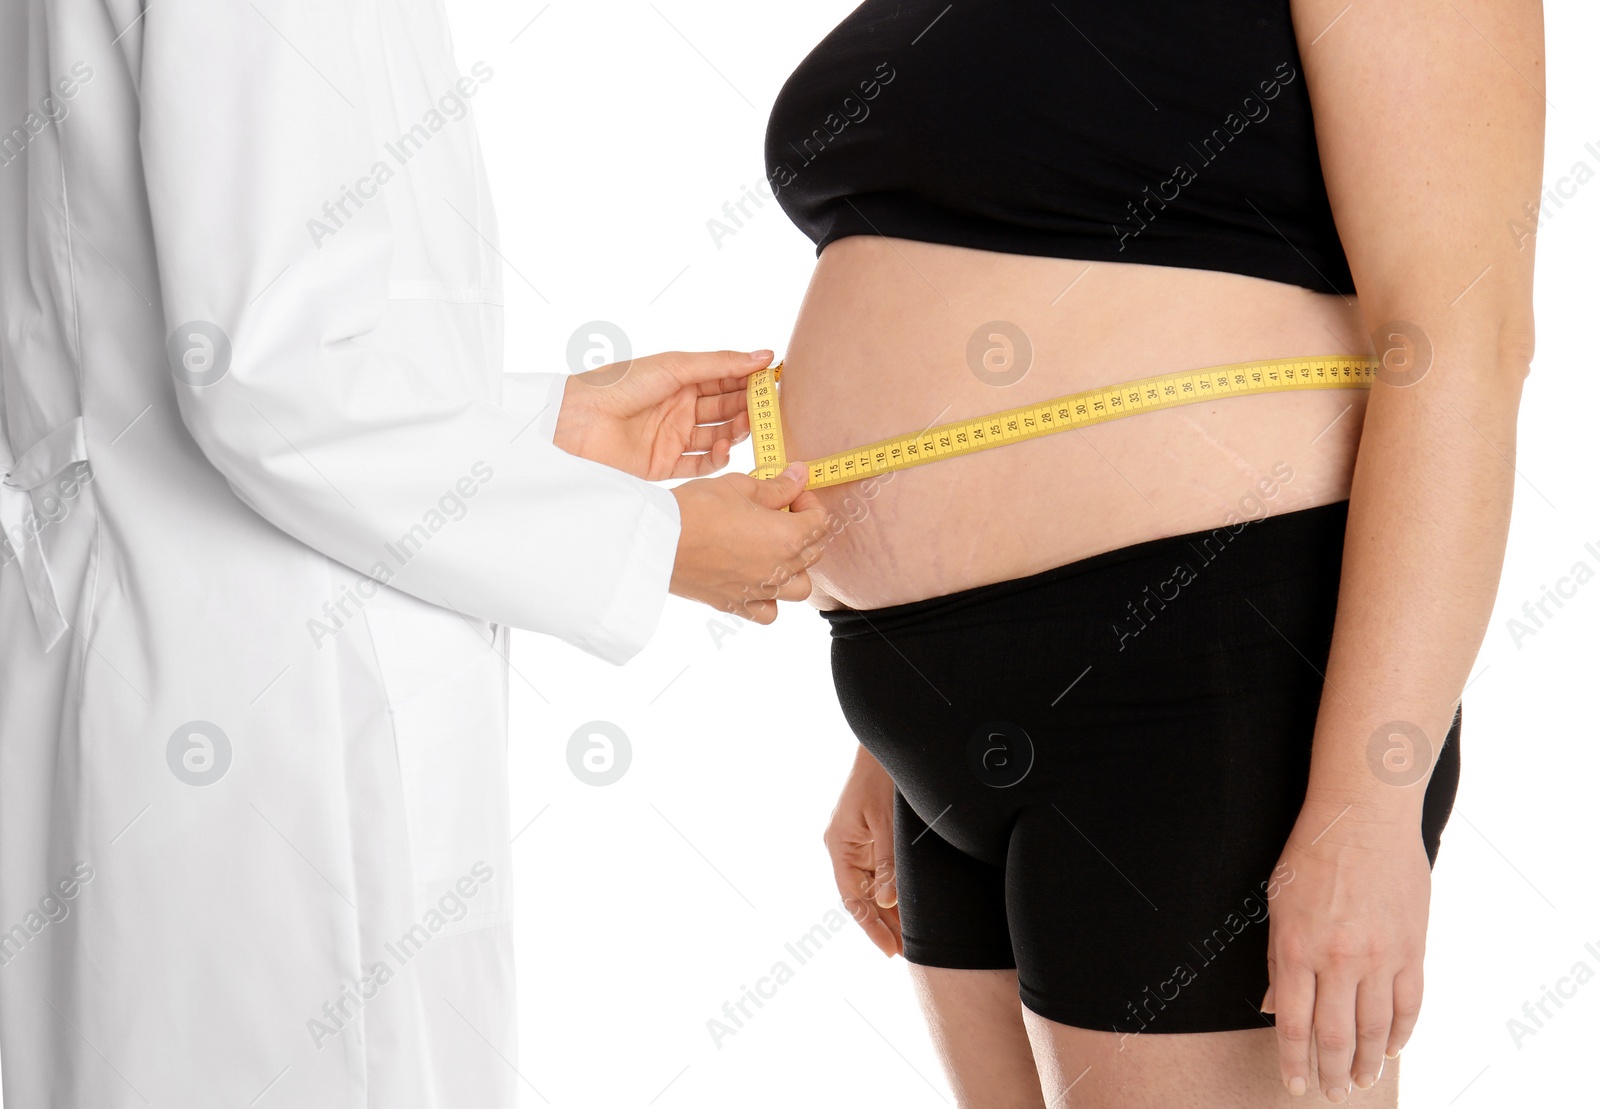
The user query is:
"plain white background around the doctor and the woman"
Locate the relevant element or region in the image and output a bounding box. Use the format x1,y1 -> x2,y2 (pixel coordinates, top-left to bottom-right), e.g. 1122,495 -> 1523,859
438,0 -> 1600,1109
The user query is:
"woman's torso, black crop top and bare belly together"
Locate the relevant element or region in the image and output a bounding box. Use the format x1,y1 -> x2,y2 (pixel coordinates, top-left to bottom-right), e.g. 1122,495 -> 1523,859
766,0 -> 1370,608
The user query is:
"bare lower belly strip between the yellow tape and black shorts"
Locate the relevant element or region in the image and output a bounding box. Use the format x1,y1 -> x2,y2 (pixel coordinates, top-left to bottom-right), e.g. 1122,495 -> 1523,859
811,425 -> 1358,610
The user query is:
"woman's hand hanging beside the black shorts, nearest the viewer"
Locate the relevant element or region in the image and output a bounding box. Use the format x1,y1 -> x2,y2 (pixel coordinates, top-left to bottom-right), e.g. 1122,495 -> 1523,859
1261,803 -> 1432,1101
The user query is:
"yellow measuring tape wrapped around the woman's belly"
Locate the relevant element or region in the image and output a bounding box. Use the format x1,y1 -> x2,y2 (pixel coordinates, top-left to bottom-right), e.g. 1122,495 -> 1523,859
749,355 -> 1381,490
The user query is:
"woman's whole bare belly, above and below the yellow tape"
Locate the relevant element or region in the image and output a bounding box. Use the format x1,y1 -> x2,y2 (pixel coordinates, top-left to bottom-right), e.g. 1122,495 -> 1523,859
782,237 -> 1371,608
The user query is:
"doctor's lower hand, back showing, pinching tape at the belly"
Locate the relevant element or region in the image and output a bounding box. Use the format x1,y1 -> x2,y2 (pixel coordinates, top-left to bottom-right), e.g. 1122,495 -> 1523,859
670,462 -> 829,624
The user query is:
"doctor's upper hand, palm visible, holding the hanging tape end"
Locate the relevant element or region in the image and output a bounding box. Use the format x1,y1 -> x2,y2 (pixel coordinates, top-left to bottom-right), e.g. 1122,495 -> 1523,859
555,350 -> 773,482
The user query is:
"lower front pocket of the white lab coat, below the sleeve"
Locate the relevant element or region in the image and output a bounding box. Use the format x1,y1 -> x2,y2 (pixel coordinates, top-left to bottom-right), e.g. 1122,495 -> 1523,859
365,591 -> 512,933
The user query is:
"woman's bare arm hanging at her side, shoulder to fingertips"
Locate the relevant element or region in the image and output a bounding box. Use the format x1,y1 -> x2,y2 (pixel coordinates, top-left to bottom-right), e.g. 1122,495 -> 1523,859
1269,0 -> 1544,1099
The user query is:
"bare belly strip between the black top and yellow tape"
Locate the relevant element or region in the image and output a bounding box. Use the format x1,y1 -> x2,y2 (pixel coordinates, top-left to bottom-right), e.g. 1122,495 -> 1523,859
782,237 -> 1370,458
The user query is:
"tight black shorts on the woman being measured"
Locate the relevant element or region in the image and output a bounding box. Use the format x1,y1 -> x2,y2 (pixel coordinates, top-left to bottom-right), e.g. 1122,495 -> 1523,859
824,502 -> 1461,1034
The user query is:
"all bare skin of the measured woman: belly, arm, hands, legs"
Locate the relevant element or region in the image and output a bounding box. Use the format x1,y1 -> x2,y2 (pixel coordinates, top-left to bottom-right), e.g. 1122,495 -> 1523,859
812,0 -> 1544,1109
